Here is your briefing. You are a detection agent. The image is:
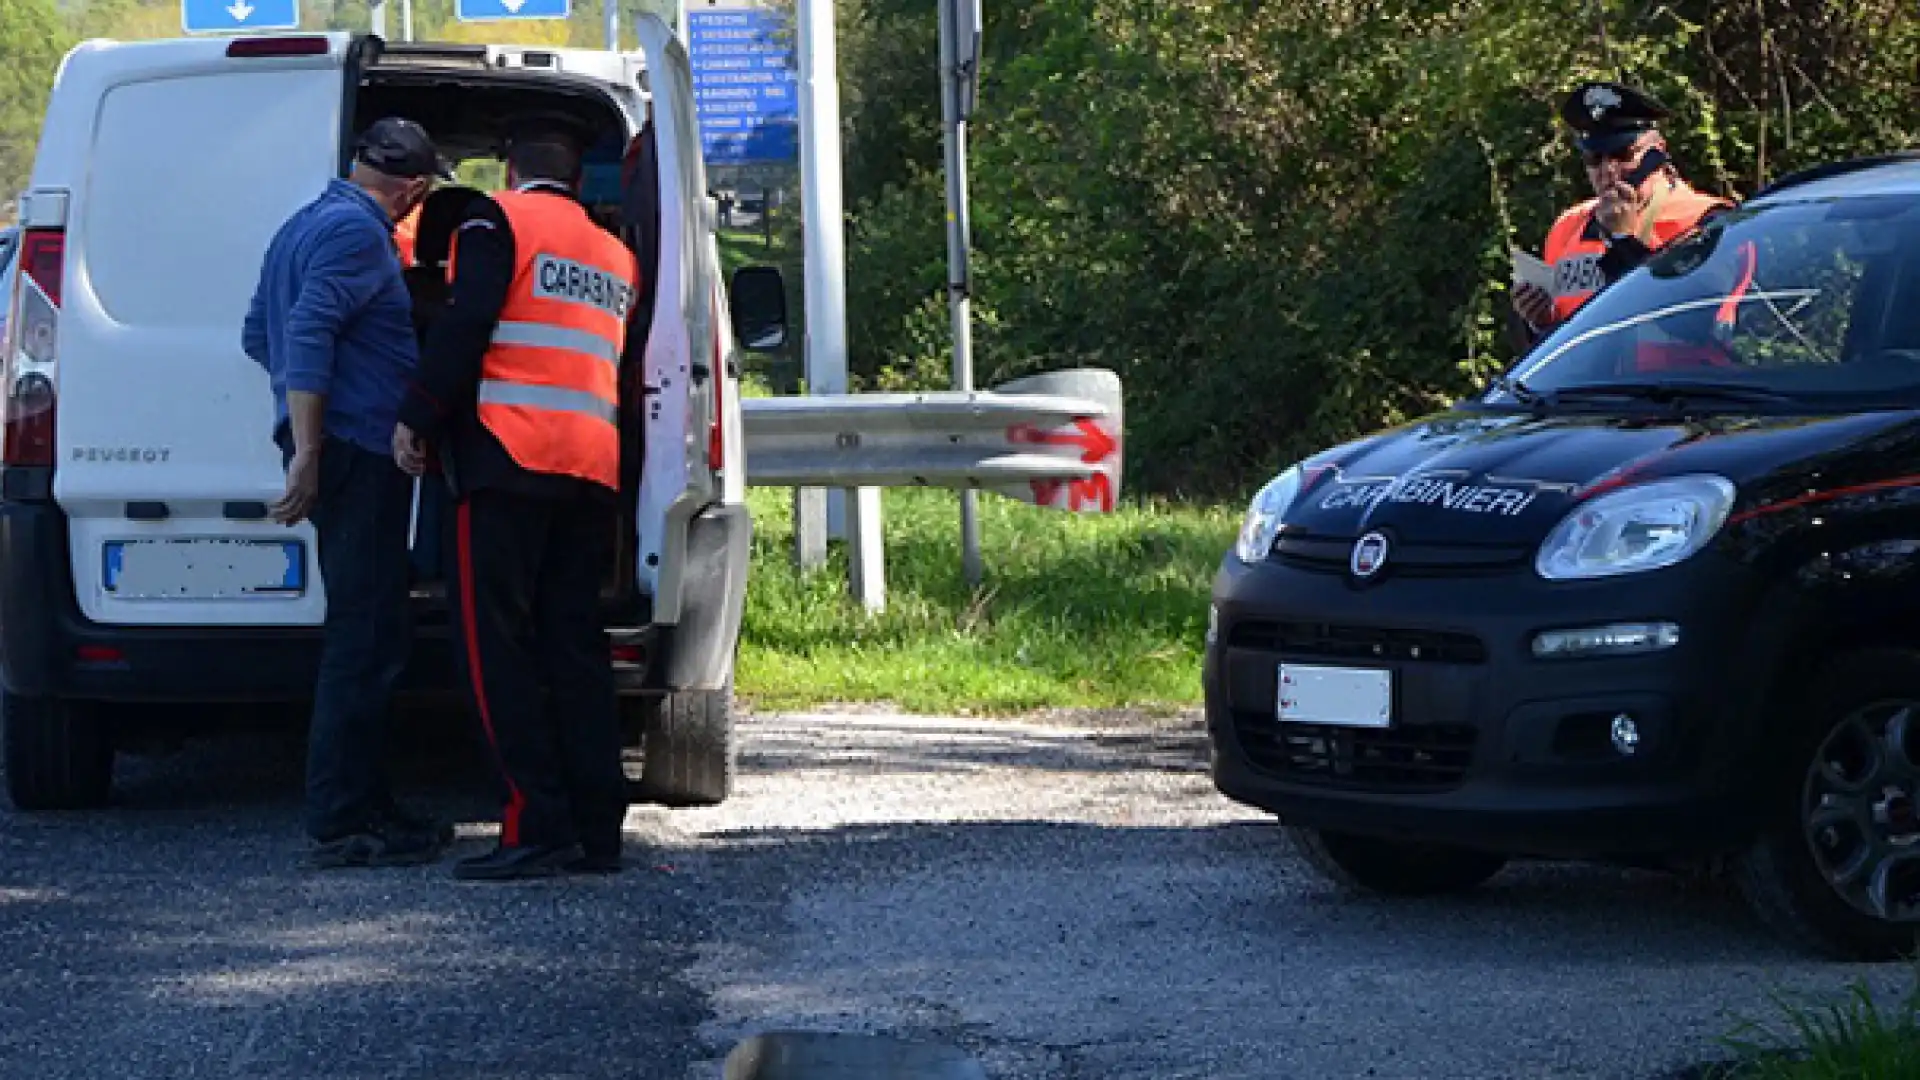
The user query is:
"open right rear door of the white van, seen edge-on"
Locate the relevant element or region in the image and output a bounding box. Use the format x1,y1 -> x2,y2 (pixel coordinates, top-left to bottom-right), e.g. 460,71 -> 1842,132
634,15 -> 739,625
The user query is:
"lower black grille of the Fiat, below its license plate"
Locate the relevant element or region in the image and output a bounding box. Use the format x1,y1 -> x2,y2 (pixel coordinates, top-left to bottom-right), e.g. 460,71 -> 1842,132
1233,713 -> 1476,792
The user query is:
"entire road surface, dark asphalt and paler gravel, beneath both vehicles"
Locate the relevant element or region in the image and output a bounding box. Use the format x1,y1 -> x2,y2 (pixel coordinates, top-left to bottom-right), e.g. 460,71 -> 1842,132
0,713 -> 1901,1080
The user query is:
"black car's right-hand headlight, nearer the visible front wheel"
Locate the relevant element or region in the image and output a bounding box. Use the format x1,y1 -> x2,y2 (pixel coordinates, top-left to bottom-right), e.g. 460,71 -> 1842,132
1534,475 -> 1736,580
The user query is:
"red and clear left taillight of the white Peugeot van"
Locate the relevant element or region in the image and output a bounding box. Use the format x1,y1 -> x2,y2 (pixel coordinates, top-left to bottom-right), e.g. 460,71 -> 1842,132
0,229 -> 67,465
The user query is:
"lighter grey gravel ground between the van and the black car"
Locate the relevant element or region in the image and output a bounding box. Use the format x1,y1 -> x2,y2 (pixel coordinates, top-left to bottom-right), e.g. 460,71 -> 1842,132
633,713 -> 1899,1080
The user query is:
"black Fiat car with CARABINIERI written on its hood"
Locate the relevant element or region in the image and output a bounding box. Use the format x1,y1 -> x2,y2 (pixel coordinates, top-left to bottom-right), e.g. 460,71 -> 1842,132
1204,154 -> 1920,959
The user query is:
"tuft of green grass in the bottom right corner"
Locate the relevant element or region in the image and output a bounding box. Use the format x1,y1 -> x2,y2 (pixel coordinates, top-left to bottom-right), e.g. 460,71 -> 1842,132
1701,969 -> 1920,1080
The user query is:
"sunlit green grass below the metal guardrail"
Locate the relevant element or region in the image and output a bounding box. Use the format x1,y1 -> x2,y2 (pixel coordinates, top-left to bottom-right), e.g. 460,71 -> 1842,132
737,488 -> 1238,713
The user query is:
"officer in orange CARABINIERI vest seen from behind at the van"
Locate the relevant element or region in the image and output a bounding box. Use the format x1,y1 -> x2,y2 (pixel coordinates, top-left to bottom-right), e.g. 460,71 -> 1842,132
394,121 -> 639,880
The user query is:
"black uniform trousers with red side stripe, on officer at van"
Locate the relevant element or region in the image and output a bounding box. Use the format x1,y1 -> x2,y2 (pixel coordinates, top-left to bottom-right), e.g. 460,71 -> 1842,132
453,488 -> 626,855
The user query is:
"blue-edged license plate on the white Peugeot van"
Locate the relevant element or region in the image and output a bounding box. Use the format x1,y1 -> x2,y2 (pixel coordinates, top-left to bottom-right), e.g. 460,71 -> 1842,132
102,538 -> 307,600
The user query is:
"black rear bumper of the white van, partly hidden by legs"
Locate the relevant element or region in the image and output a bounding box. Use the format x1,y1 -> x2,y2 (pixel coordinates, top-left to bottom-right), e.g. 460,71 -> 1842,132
0,502 -> 643,703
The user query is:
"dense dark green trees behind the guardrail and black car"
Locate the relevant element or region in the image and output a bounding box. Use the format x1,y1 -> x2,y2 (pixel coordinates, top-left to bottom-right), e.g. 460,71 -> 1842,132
843,0 -> 1920,494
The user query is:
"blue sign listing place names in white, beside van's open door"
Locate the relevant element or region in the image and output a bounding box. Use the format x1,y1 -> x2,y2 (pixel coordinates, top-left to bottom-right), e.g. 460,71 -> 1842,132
687,8 -> 801,165
